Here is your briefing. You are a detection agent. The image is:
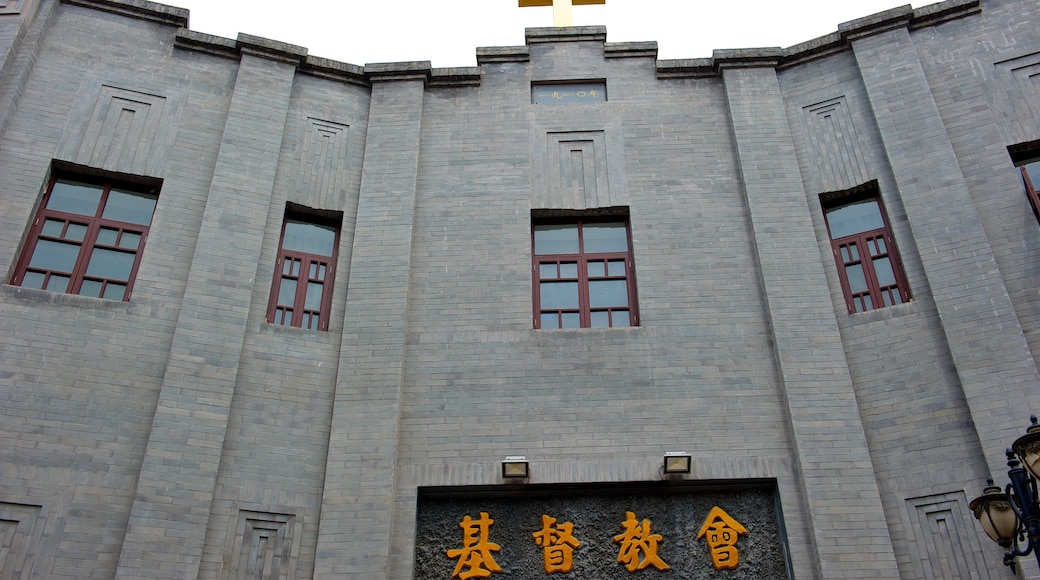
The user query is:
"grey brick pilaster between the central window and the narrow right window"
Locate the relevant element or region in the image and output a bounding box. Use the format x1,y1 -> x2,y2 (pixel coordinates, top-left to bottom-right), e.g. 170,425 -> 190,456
716,55 -> 899,580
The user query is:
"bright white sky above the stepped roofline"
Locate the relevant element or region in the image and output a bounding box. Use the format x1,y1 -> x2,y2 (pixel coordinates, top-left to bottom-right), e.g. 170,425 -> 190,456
160,0 -> 911,68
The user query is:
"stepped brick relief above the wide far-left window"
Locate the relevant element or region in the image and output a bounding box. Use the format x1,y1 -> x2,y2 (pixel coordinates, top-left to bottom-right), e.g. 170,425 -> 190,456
57,83 -> 176,176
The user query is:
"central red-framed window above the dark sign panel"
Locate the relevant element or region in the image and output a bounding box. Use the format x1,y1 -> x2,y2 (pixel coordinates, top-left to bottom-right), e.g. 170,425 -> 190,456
531,216 -> 639,328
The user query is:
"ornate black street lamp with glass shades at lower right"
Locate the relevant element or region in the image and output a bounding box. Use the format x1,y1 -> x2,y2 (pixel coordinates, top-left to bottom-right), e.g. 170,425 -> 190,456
968,416 -> 1040,573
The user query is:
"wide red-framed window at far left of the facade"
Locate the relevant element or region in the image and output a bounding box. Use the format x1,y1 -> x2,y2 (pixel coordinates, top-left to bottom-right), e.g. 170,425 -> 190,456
11,177 -> 159,301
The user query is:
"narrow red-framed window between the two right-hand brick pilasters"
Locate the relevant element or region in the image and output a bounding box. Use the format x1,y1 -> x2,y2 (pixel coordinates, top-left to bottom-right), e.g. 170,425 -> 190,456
824,193 -> 910,314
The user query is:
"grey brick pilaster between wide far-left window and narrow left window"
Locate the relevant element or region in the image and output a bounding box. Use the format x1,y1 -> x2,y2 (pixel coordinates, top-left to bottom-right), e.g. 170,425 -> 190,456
116,50 -> 295,579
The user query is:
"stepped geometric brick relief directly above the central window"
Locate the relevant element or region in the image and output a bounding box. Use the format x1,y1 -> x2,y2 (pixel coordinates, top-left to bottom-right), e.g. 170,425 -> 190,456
531,131 -> 615,210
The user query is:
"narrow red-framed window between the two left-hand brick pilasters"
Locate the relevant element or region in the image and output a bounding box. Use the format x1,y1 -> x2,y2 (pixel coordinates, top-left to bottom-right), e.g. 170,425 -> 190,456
267,211 -> 340,331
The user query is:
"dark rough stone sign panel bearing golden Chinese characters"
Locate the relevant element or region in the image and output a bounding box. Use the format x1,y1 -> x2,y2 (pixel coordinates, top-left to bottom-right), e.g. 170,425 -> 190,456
415,480 -> 791,580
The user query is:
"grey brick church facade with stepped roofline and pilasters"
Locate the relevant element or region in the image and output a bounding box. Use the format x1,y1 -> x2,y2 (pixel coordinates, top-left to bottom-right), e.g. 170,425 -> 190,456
0,0 -> 1040,580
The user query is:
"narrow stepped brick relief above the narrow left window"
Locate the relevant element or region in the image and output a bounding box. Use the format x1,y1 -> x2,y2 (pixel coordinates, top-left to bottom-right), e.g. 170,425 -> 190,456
289,117 -> 349,208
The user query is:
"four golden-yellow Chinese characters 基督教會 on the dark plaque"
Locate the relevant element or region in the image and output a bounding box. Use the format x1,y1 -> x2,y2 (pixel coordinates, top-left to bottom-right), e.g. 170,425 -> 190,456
447,506 -> 748,580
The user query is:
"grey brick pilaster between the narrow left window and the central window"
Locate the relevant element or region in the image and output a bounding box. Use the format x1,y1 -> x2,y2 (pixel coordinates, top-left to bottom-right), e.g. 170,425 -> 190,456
314,62 -> 430,578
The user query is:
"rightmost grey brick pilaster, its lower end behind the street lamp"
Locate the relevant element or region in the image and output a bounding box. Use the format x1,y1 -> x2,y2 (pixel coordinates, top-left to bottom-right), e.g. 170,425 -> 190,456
852,23 -> 1040,478
